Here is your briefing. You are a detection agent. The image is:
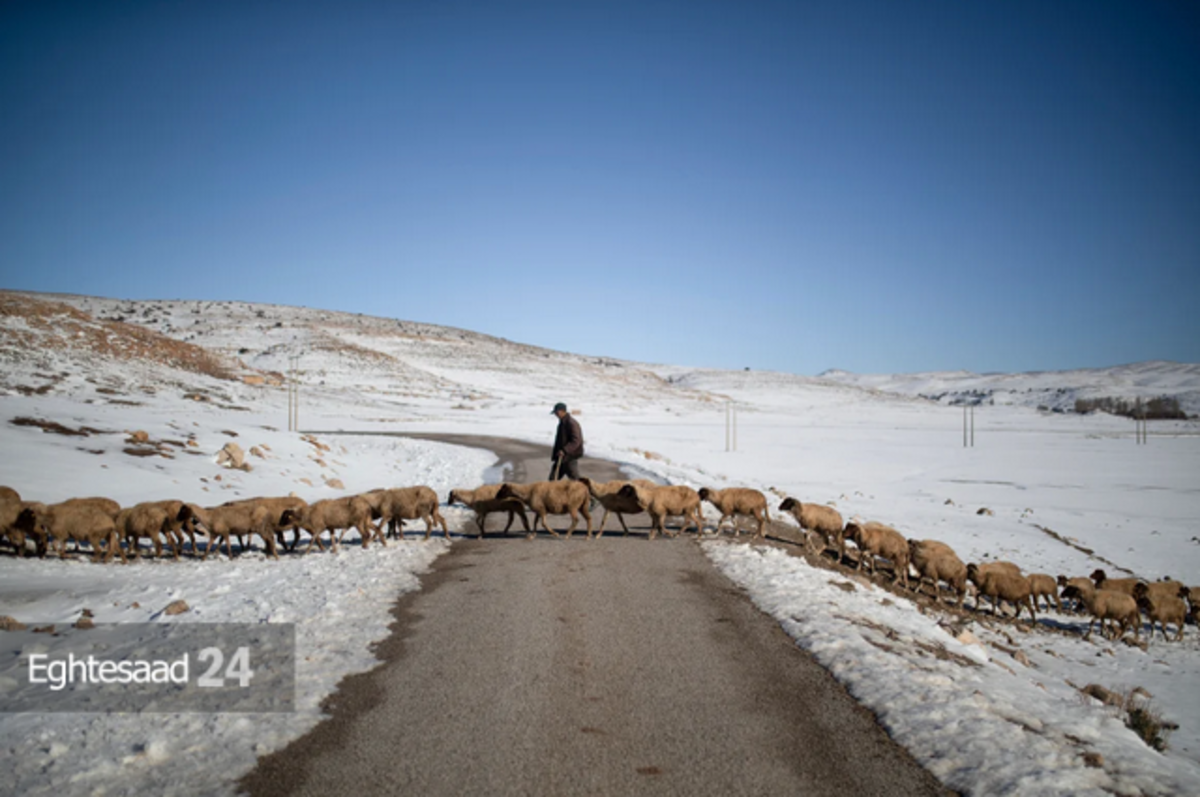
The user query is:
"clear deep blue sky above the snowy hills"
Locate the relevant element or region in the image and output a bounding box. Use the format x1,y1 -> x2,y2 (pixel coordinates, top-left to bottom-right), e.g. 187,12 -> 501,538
0,0 -> 1200,373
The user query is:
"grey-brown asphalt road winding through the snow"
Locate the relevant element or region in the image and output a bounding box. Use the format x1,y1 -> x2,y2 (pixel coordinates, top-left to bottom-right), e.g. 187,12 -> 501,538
241,437 -> 946,796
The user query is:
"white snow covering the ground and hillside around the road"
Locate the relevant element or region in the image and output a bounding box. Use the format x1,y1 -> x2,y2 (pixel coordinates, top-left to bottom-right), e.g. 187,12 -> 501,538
0,296 -> 1200,793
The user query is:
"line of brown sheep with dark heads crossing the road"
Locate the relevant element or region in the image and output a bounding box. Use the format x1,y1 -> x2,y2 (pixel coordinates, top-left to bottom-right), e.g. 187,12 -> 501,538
0,478 -> 1200,640
